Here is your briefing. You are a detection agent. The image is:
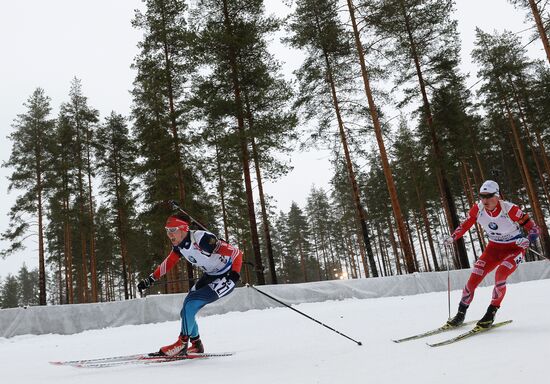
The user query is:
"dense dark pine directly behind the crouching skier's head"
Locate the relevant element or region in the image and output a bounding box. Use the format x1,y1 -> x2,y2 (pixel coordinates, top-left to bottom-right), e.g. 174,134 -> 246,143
132,0 -> 203,291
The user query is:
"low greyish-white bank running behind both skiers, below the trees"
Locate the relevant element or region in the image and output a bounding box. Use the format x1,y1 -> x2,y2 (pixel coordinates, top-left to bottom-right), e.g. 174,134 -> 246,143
0,261 -> 550,337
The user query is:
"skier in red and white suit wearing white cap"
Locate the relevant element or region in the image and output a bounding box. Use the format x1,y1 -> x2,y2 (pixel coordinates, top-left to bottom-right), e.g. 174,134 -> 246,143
444,180 -> 540,328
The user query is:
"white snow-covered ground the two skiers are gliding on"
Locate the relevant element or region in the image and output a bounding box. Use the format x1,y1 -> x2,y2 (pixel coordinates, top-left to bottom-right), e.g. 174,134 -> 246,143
0,280 -> 550,384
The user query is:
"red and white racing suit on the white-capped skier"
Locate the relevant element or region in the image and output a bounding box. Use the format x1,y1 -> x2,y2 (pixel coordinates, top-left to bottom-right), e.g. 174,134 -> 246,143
451,200 -> 540,307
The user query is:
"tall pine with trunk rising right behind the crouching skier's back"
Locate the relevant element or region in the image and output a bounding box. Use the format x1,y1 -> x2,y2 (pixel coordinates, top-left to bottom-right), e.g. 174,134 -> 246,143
193,0 -> 286,284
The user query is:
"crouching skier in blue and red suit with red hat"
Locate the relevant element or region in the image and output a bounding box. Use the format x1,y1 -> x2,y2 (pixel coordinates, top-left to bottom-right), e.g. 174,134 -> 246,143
138,216 -> 243,356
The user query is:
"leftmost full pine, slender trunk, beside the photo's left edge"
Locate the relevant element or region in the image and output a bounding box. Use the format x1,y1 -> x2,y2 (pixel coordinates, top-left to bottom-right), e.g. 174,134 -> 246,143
2,88 -> 54,305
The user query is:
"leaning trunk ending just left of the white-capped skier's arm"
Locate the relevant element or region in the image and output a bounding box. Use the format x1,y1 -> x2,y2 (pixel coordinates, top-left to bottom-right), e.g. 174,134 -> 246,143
401,0 -> 470,268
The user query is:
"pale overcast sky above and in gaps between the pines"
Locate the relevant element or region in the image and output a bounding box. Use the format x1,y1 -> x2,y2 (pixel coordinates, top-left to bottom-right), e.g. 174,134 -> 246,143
0,0 -> 543,277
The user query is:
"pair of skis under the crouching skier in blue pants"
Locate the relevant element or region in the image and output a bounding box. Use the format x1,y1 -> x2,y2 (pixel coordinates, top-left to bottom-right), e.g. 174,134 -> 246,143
50,352 -> 234,368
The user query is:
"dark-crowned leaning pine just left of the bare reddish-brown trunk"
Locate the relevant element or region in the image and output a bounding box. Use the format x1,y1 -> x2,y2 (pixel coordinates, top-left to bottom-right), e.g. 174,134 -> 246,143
288,0 -> 378,277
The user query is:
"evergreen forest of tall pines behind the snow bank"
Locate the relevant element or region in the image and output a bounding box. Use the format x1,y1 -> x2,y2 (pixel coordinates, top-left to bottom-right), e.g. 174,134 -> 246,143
0,0 -> 550,308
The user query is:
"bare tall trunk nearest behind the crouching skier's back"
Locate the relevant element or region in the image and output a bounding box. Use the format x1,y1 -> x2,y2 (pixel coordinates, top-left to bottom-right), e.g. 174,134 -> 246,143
223,0 -> 265,285
